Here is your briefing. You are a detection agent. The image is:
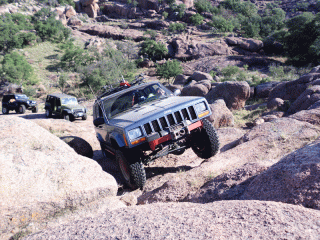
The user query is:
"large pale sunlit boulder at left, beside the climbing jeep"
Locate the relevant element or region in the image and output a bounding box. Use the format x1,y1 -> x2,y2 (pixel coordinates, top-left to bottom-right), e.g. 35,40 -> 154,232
0,116 -> 118,233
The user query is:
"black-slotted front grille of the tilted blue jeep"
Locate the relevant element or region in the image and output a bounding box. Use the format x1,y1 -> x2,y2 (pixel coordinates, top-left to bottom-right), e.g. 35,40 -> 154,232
143,106 -> 197,134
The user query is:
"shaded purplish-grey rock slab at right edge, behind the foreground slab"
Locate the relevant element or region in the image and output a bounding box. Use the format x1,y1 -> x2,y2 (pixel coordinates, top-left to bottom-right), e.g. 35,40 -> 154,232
241,139 -> 320,210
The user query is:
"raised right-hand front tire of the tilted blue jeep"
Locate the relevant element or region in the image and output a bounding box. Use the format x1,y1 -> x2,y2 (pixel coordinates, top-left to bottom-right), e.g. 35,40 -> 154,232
191,119 -> 220,159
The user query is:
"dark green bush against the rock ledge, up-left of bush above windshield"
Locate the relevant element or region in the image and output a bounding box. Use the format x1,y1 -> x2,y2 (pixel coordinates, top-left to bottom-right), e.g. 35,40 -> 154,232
140,39 -> 168,60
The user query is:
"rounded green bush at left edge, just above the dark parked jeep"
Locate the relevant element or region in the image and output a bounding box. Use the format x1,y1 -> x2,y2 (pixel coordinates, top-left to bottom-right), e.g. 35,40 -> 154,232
0,52 -> 35,85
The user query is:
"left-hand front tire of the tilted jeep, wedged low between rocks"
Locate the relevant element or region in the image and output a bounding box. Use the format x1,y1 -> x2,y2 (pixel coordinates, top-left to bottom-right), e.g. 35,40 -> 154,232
116,150 -> 146,190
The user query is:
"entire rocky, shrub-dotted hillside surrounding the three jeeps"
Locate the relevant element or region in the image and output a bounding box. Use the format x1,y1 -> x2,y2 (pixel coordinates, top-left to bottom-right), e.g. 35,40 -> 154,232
0,0 -> 320,239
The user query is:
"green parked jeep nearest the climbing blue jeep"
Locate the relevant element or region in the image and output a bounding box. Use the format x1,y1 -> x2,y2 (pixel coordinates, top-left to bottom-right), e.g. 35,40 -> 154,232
44,93 -> 87,121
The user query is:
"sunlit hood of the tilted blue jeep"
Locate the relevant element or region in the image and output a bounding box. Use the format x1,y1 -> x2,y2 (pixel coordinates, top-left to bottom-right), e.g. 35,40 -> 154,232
109,97 -> 203,128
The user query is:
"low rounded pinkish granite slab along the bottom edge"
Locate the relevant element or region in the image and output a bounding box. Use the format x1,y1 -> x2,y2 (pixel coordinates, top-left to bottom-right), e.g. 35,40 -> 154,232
24,201 -> 320,240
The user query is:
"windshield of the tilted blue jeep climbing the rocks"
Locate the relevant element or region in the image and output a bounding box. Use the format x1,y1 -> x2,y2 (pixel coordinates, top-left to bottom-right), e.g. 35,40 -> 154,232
104,83 -> 172,118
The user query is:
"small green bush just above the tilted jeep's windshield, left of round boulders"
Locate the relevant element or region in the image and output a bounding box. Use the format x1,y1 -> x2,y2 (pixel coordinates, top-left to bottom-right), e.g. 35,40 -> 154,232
156,59 -> 183,82
